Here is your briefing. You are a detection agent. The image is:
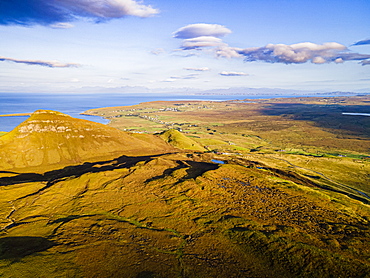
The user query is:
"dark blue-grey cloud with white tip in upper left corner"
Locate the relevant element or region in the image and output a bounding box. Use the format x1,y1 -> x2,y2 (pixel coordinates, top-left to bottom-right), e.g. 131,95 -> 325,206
0,0 -> 159,28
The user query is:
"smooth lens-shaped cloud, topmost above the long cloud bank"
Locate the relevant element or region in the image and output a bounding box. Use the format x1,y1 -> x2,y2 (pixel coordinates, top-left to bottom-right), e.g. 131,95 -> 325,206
173,23 -> 231,39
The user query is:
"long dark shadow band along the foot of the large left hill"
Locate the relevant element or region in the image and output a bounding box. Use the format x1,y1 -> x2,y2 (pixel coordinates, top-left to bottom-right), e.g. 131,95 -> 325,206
0,154 -> 169,190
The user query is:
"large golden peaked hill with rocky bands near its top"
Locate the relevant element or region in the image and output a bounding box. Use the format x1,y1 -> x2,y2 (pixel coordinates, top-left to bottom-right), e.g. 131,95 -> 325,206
0,110 -> 171,169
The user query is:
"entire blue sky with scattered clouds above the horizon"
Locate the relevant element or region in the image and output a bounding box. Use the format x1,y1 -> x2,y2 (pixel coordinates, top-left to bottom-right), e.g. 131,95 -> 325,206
0,0 -> 370,93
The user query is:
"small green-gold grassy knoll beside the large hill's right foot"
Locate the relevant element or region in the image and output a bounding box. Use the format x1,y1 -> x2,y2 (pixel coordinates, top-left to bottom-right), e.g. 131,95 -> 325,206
160,129 -> 206,151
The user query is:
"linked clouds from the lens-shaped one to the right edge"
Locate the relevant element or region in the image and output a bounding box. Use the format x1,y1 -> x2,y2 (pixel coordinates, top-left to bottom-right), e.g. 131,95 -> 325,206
173,23 -> 370,65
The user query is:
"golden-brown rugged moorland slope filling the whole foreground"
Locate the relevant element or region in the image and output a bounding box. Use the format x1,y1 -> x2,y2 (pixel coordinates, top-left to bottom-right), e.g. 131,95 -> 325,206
0,152 -> 370,278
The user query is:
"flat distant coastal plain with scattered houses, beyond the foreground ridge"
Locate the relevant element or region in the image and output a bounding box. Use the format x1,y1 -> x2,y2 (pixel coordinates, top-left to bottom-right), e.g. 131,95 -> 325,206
87,96 -> 370,203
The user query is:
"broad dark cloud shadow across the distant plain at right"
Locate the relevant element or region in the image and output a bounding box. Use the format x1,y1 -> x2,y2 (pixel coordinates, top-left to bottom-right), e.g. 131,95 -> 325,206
261,103 -> 370,139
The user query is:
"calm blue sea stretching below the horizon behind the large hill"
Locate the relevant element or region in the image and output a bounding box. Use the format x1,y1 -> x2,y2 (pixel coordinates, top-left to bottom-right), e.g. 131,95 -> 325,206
0,92 -> 362,131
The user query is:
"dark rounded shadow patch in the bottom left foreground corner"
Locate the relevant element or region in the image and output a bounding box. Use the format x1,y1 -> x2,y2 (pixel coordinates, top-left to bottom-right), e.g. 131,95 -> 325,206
0,236 -> 55,260
